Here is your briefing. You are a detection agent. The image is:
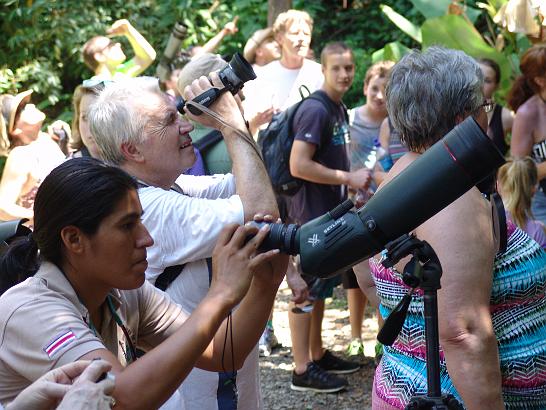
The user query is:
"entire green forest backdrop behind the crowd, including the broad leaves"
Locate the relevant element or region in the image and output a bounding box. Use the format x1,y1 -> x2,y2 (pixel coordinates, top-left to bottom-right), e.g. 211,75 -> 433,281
0,0 -> 531,120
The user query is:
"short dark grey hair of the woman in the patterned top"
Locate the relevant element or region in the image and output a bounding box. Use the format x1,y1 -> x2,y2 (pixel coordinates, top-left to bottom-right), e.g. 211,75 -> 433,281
386,46 -> 483,151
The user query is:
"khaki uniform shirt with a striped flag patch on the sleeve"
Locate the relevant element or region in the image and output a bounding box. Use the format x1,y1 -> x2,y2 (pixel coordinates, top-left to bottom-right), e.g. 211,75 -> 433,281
0,262 -> 188,404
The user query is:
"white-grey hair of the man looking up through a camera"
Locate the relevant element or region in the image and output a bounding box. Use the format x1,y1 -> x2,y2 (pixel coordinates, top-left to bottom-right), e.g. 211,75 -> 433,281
88,77 -> 162,165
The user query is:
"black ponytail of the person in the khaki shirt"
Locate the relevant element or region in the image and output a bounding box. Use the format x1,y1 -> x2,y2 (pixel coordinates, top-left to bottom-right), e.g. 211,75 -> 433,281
0,234 -> 39,295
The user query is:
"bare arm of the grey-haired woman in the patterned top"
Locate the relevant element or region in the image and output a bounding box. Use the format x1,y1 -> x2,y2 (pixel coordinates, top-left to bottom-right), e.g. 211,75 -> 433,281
416,189 -> 503,409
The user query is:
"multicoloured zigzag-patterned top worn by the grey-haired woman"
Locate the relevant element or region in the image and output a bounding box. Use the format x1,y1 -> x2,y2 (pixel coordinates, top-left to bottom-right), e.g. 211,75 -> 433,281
370,221 -> 546,409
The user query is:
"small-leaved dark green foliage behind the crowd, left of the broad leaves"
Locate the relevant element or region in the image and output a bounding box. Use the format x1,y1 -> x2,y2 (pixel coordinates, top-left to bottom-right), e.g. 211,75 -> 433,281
0,0 -> 418,115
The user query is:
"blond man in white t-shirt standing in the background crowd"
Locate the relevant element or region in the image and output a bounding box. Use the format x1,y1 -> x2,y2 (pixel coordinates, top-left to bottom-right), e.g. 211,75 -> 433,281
243,10 -> 324,136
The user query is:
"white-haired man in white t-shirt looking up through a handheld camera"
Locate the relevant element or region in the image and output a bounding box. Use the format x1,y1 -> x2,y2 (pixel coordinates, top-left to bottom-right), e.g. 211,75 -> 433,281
90,73 -> 286,410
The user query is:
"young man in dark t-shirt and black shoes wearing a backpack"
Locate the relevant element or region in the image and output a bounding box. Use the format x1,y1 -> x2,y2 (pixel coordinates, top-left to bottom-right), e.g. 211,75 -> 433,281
288,42 -> 371,393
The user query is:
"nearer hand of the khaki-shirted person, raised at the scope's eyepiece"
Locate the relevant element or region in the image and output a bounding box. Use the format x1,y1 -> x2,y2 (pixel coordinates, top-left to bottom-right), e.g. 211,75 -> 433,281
209,224 -> 279,307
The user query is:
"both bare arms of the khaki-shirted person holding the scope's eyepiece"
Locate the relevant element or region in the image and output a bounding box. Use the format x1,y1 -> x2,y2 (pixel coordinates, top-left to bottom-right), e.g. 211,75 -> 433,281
82,225 -> 286,409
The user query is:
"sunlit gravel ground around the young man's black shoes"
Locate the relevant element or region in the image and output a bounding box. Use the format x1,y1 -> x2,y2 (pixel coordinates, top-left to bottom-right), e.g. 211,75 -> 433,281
260,284 -> 377,410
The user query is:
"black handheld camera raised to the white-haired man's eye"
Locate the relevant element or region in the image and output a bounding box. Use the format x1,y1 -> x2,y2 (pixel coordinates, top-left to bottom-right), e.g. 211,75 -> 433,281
176,53 -> 256,115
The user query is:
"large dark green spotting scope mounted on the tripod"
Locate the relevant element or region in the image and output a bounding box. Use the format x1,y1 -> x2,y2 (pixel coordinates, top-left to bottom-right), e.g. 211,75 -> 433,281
251,117 -> 506,278
